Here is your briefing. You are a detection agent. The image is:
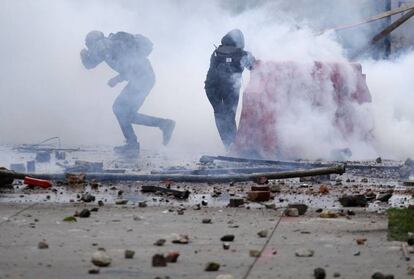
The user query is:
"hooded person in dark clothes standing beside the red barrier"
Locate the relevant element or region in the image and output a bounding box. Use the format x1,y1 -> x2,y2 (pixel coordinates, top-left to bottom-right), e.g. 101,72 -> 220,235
204,29 -> 255,149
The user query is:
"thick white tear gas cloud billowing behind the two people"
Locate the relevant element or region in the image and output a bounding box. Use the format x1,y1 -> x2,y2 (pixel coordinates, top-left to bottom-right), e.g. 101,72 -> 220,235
0,0 -> 414,161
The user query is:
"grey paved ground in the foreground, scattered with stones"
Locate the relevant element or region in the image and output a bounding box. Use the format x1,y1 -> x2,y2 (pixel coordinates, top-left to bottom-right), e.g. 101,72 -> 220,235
0,203 -> 414,279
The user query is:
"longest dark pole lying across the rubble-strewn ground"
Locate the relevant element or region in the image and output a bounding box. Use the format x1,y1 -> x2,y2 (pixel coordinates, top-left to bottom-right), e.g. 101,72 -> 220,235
0,165 -> 345,183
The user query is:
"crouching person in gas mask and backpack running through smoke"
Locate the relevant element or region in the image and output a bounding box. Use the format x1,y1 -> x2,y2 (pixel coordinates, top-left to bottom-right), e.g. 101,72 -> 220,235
80,31 -> 175,155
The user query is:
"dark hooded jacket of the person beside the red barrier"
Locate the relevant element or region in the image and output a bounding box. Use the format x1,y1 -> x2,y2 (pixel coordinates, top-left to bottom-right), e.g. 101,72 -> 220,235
206,29 -> 255,86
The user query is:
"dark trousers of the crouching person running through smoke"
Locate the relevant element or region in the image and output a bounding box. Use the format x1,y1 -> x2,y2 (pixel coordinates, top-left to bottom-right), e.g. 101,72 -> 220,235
112,82 -> 165,143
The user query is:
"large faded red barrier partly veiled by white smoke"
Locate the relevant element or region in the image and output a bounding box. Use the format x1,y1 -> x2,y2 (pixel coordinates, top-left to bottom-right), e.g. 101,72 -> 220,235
230,61 -> 371,158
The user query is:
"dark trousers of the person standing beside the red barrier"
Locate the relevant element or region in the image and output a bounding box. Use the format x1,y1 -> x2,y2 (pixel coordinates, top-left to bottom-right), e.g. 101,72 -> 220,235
205,77 -> 240,148
